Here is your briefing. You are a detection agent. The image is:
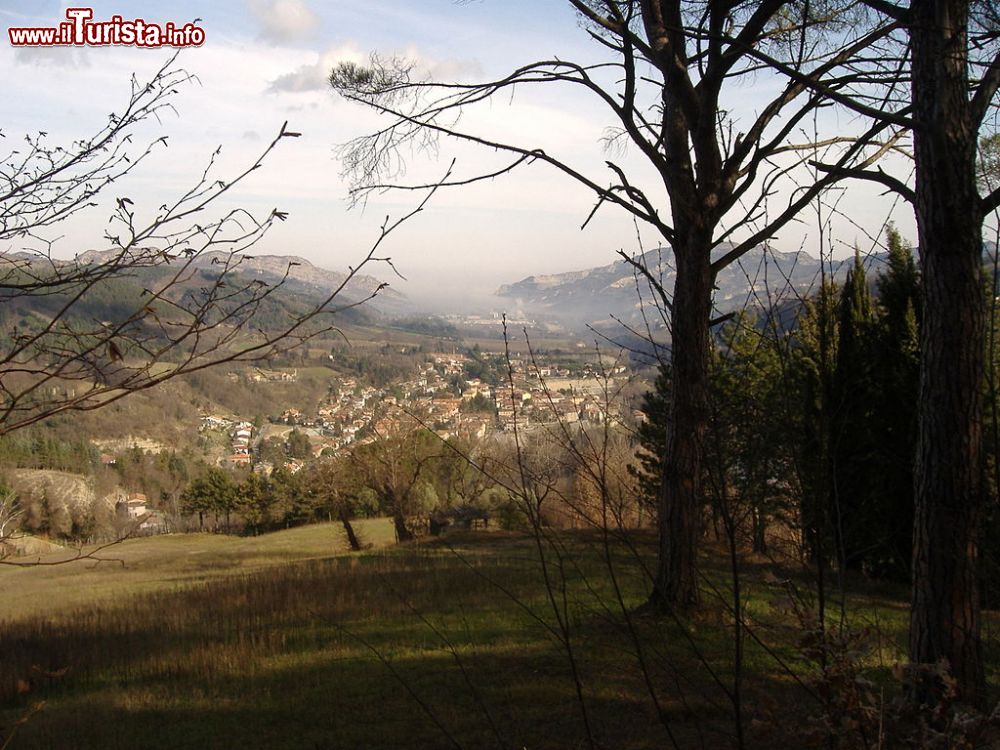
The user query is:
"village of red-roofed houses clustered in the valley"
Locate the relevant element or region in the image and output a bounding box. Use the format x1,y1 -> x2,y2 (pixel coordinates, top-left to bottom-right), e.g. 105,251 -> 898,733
199,351 -> 644,475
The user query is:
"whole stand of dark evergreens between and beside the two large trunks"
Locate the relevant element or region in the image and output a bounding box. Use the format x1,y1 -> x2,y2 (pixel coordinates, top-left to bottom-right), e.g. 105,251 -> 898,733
637,229 -> 936,580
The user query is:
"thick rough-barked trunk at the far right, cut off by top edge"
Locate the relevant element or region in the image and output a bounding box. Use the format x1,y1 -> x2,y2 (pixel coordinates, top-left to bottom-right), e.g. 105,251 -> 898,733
910,0 -> 985,700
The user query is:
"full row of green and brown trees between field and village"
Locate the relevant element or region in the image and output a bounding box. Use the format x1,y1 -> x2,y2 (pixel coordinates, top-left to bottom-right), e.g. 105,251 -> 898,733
179,422 -> 650,548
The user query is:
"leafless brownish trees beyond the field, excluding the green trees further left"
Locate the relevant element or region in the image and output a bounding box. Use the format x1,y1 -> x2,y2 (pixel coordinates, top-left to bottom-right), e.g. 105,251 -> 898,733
320,425 -> 636,541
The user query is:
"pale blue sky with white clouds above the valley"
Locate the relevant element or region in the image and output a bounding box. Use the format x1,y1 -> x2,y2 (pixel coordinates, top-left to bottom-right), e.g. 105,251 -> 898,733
0,0 -> 914,309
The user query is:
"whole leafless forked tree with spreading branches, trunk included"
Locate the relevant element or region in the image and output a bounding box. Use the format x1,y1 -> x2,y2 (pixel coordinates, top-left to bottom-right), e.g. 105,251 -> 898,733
330,0 -> 901,608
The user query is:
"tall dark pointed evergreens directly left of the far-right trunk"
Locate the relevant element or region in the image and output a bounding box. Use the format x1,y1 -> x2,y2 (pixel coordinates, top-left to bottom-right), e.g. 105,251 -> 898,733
794,236 -> 920,578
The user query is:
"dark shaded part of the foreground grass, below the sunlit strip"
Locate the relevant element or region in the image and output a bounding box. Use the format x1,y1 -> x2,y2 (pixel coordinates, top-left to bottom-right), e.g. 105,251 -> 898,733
0,535 -> 952,749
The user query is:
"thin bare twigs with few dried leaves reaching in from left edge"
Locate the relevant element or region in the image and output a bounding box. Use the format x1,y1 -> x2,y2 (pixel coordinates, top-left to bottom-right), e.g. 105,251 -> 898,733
0,58 -> 434,434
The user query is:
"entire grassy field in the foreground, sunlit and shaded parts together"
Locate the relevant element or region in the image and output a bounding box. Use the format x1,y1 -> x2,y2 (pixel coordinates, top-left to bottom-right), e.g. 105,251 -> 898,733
0,525 -> 995,749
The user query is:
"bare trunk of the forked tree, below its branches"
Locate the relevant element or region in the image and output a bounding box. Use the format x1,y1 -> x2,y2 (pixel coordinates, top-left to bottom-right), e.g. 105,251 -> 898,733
651,243 -> 712,609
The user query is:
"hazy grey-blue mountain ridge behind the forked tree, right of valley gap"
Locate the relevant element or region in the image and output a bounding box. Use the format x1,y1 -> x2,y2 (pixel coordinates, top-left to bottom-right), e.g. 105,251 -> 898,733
496,245 -> 885,327
